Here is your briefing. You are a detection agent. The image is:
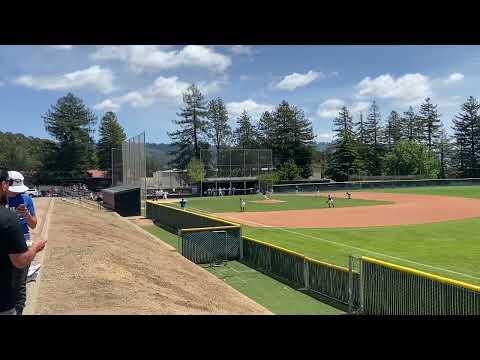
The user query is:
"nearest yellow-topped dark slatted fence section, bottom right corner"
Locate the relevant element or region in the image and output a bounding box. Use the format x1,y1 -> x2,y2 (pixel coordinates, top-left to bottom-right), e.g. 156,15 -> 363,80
361,257 -> 480,315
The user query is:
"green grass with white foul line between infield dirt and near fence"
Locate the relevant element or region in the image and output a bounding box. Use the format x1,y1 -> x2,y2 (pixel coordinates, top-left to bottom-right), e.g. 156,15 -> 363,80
243,219 -> 480,285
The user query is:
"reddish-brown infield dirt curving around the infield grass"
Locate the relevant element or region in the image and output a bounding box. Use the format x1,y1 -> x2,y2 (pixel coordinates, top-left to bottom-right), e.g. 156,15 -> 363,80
214,192 -> 480,228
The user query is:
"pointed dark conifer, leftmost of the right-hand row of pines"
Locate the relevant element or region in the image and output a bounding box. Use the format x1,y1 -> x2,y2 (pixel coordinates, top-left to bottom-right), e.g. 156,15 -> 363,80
330,106 -> 358,181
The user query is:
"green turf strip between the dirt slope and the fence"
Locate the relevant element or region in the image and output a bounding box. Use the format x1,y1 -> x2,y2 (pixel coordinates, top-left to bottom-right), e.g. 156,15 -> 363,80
143,225 -> 344,315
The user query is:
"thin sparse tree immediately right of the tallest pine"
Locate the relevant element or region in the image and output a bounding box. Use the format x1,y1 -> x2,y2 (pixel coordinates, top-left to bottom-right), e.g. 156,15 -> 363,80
207,97 -> 232,159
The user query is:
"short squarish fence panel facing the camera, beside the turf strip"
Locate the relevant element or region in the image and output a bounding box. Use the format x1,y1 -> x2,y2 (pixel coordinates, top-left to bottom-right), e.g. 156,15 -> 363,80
179,226 -> 240,264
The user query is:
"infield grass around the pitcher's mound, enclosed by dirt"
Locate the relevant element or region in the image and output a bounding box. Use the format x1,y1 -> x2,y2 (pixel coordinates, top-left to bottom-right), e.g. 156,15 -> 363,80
167,194 -> 389,213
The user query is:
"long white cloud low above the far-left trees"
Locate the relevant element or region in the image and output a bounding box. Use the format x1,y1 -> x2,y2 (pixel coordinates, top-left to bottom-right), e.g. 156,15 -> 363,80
14,65 -> 114,93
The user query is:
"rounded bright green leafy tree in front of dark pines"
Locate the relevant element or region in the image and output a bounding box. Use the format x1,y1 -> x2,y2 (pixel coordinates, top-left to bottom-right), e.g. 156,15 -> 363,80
384,140 -> 440,179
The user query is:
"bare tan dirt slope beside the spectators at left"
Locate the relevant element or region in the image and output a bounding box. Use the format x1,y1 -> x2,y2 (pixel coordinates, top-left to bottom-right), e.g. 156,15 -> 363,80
26,199 -> 270,314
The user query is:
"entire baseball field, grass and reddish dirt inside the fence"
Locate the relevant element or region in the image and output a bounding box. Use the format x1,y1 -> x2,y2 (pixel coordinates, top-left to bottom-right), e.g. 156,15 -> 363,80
167,186 -> 480,284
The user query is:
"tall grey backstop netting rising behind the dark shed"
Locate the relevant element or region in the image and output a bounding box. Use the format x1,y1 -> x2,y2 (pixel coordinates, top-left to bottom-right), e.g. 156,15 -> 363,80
112,132 -> 147,209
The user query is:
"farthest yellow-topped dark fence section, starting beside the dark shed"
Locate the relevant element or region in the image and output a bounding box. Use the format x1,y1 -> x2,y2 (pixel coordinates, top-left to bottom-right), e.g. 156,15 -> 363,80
146,201 -> 238,234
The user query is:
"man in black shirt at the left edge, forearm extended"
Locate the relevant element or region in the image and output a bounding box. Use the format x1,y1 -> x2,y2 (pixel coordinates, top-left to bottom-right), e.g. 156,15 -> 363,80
0,169 -> 46,315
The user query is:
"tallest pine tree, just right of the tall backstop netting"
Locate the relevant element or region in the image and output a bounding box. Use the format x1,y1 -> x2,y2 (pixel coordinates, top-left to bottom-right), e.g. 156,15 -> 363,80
168,84 -> 208,169
